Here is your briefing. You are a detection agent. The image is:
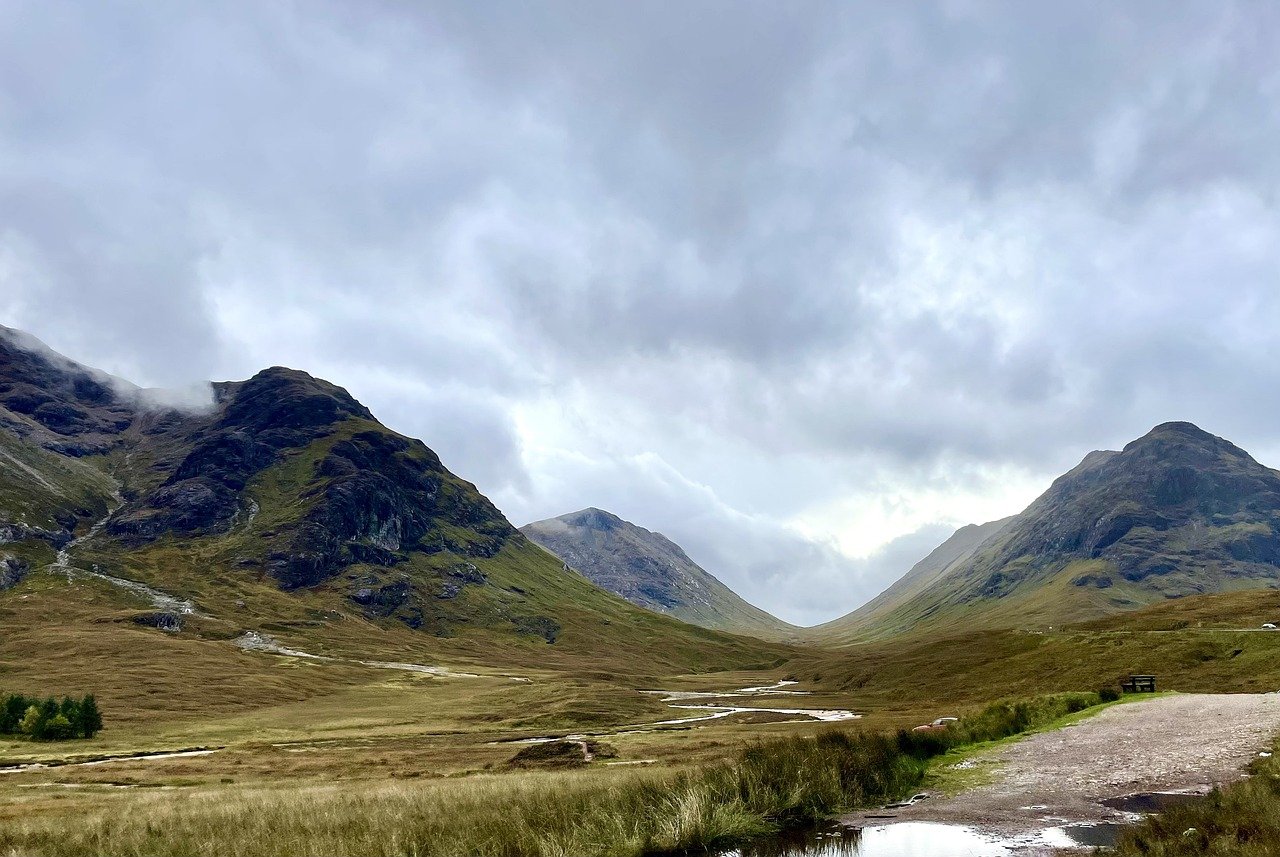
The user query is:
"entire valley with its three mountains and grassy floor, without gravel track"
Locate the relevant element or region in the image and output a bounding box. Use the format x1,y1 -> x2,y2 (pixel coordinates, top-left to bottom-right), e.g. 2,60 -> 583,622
0,330 -> 1280,857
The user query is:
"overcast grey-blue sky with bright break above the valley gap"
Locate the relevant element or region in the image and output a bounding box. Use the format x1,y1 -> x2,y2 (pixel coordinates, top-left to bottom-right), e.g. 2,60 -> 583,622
0,0 -> 1280,624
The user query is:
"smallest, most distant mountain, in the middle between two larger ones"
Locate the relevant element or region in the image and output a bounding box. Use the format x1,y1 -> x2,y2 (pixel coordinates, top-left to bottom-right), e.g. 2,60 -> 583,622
520,509 -> 799,638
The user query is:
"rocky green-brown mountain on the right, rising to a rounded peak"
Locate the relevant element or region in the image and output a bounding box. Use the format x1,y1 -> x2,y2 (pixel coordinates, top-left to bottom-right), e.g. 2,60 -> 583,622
813,422 -> 1280,642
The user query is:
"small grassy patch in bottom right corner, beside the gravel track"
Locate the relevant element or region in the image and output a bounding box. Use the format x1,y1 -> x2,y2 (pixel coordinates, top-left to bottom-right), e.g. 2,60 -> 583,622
1116,741 -> 1280,857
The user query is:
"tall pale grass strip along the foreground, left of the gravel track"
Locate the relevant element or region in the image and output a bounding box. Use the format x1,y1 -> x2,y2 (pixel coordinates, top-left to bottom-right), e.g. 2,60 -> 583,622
0,693 -> 1098,857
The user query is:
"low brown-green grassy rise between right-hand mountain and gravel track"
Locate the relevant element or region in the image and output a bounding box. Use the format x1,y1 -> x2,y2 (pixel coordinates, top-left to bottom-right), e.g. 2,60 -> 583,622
791,590 -> 1280,719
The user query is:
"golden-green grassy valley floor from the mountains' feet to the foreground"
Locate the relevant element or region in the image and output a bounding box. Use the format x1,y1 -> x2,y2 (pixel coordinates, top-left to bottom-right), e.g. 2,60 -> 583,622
0,534 -> 1280,854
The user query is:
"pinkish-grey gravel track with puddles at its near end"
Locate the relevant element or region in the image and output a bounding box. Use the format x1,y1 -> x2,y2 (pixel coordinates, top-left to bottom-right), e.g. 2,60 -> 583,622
847,693 -> 1280,834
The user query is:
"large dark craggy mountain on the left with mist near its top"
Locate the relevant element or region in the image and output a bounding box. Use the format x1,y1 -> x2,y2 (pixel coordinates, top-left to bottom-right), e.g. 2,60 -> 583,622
0,327 -> 776,670
